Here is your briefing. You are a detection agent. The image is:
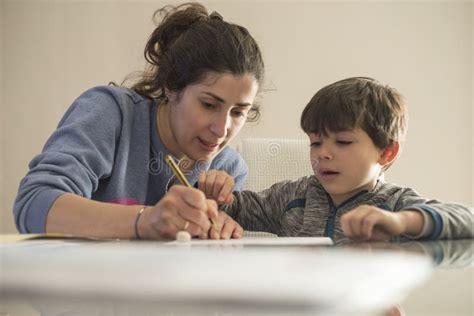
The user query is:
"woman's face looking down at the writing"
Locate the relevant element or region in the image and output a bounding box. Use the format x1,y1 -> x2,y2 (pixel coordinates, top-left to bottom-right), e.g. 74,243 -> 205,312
167,73 -> 258,161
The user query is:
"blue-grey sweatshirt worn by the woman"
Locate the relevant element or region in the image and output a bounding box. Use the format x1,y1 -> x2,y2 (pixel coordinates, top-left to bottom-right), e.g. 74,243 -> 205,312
13,86 -> 248,233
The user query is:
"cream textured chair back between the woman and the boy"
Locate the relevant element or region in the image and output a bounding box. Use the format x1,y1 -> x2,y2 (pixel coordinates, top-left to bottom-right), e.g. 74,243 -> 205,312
236,138 -> 313,191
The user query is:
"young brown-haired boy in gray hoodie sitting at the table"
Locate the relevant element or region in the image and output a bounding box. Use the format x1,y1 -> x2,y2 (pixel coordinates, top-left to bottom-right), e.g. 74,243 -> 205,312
199,77 -> 474,241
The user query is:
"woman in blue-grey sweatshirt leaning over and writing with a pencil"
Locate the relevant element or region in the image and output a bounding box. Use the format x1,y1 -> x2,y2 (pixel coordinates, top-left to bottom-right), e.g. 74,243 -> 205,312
14,3 -> 264,239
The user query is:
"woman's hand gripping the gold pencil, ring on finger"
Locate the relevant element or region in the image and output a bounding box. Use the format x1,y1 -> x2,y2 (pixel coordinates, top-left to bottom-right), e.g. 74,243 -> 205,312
138,185 -> 219,239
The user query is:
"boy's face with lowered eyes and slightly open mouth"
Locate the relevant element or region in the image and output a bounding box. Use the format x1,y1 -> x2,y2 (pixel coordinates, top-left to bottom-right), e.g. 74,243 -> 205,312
308,128 -> 384,205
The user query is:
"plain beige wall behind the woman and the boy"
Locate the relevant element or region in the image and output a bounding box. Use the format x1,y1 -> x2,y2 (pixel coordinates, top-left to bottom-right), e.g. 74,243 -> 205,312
0,0 -> 474,233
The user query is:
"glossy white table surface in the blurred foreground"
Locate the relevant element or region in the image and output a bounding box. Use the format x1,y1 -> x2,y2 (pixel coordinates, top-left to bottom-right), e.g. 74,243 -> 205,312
0,236 -> 473,316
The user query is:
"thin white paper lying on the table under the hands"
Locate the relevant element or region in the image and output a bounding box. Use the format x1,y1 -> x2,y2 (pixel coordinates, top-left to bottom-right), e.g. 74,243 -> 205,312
166,237 -> 332,246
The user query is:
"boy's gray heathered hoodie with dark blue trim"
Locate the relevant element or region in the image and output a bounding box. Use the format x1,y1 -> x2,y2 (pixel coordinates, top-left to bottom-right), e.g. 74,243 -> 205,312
226,176 -> 474,241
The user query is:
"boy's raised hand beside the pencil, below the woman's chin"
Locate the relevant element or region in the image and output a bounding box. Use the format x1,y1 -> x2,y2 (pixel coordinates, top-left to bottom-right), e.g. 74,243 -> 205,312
198,170 -> 234,204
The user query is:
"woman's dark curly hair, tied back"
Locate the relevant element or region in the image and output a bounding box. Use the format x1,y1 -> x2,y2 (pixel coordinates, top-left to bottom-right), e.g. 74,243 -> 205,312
131,2 -> 265,121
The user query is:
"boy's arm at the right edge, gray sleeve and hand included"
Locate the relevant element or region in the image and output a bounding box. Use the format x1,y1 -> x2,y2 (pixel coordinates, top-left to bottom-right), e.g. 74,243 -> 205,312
341,189 -> 474,240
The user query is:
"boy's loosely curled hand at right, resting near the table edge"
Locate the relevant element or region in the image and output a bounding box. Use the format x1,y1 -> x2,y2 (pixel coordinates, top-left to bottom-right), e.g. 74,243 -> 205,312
341,205 -> 423,241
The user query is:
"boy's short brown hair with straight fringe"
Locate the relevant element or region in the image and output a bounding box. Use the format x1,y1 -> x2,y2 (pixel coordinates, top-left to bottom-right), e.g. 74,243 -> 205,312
301,77 -> 408,149
